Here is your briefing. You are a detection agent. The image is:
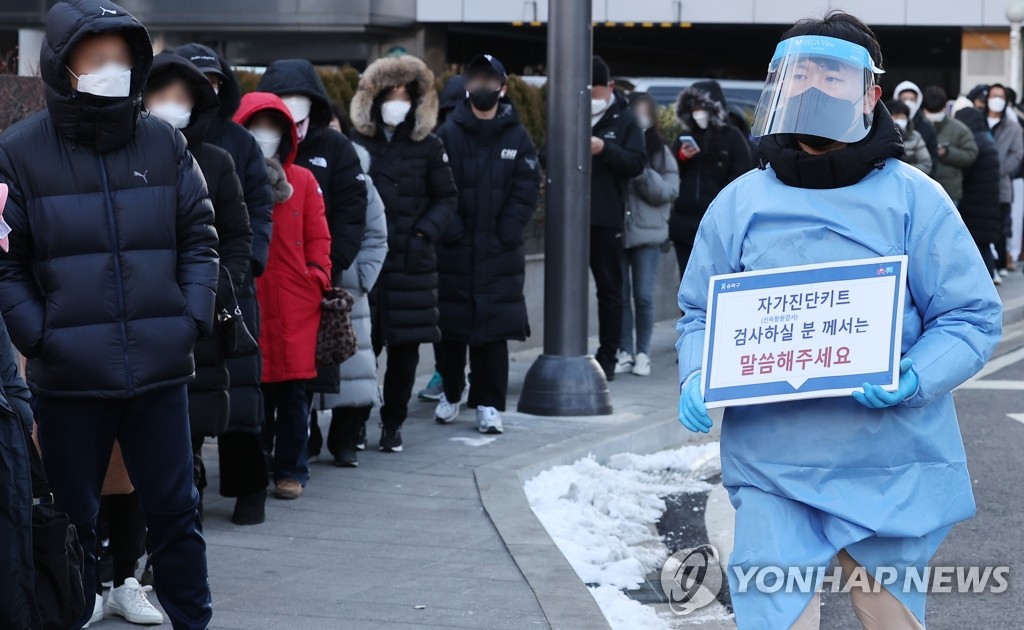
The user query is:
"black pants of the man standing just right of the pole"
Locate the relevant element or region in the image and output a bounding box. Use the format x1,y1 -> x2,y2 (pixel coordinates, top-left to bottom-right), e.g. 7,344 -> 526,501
590,225 -> 624,358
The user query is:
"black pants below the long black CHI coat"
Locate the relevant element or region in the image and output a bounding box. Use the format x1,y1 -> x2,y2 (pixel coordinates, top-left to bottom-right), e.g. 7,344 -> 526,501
441,341 -> 509,411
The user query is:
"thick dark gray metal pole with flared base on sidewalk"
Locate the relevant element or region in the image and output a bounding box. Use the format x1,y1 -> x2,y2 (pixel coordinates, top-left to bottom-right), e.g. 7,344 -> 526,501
519,0 -> 611,416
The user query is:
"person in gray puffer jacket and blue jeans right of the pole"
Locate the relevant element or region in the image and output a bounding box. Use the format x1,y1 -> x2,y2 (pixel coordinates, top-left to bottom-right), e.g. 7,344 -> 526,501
615,93 -> 679,376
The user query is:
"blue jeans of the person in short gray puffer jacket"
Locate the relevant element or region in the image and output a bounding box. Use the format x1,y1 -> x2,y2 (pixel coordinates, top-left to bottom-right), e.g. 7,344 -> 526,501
618,245 -> 660,354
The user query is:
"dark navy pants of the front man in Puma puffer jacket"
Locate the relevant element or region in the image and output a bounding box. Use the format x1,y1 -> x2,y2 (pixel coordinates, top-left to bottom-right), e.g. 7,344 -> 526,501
36,385 -> 213,629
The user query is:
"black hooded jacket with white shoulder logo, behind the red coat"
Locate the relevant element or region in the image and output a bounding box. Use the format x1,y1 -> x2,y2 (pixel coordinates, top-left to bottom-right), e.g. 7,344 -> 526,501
259,59 -> 367,271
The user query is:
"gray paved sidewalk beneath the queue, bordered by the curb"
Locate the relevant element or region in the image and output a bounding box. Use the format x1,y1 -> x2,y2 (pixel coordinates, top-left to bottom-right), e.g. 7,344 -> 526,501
92,322 -> 696,630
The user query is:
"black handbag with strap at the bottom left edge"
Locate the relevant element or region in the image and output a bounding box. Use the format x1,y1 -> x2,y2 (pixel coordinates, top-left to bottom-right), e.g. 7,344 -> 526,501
14,418 -> 85,630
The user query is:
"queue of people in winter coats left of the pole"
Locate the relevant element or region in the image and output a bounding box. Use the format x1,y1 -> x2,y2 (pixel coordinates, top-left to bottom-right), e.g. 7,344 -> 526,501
0,0 -> 541,628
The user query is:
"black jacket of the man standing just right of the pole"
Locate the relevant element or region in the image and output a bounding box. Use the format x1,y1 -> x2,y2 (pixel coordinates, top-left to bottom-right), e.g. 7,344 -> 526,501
590,91 -> 645,229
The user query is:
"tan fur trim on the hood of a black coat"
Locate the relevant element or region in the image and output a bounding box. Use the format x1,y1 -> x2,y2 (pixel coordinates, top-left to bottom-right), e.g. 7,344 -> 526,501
349,54 -> 438,142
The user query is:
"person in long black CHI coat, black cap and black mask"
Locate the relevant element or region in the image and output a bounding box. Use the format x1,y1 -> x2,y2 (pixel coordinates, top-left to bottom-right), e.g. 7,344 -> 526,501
435,55 -> 541,433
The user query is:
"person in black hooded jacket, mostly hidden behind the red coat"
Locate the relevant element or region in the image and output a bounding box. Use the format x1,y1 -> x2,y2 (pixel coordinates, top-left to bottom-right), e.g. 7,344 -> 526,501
259,59 -> 367,460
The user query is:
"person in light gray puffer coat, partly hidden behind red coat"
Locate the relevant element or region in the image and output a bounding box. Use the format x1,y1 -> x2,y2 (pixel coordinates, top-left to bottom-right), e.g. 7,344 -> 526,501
316,144 -> 387,467
